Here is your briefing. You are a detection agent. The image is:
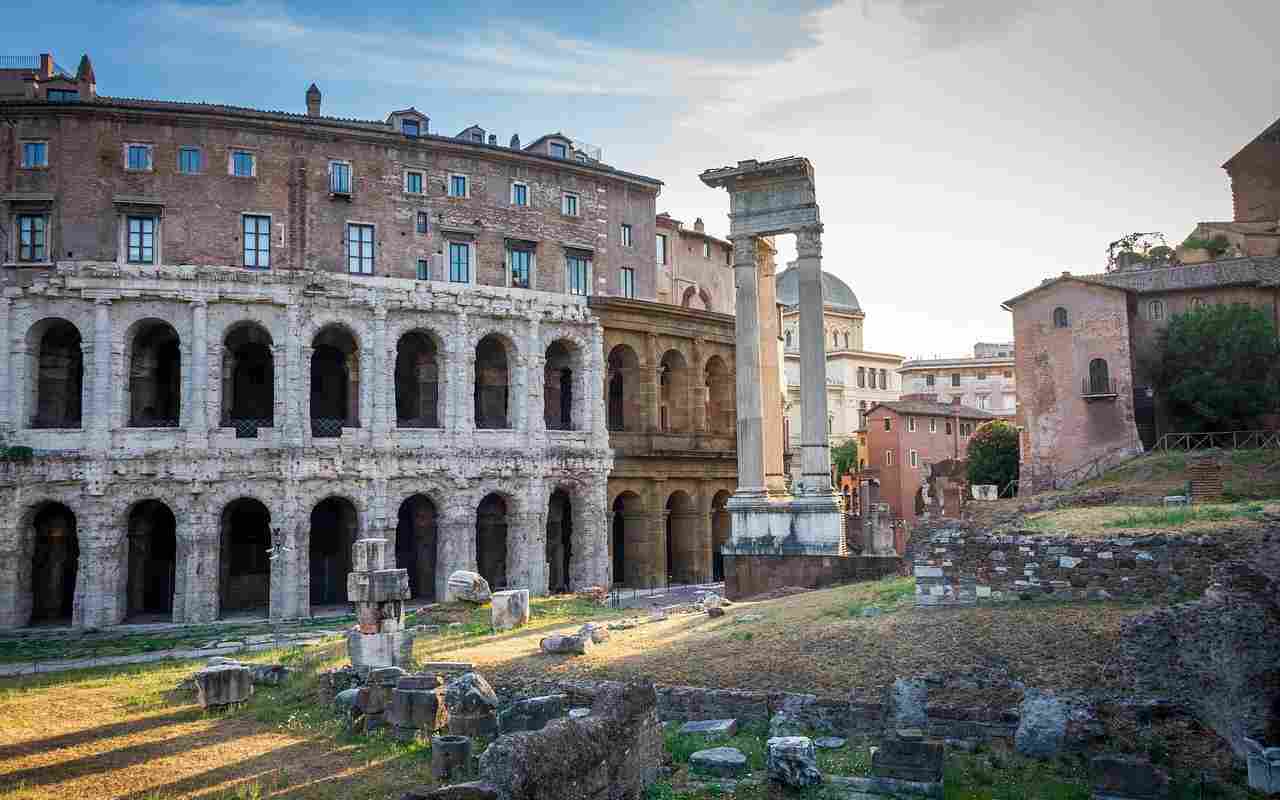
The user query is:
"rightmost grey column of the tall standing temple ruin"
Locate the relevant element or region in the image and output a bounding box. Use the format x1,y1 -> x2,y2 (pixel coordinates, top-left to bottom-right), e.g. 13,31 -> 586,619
796,225 -> 832,494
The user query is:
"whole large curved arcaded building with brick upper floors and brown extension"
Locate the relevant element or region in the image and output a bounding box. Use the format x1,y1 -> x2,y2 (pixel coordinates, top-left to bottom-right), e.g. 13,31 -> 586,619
0,53 -> 733,627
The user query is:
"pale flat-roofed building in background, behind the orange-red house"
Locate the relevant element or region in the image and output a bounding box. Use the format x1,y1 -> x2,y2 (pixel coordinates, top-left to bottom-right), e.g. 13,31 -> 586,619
899,342 -> 1018,419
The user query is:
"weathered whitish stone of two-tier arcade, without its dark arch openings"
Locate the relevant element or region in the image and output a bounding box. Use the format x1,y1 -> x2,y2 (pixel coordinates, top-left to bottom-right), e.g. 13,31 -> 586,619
0,264 -> 612,627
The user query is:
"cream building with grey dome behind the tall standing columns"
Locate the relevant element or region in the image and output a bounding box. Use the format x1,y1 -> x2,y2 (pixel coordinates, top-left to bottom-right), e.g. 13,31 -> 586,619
776,265 -> 902,468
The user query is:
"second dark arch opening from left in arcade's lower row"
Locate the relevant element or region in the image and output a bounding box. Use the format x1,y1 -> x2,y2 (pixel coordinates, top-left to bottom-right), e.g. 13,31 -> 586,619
123,499 -> 178,622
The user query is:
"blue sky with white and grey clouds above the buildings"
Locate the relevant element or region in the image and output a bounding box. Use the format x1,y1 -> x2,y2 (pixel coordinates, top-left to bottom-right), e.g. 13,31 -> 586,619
10,0 -> 1280,357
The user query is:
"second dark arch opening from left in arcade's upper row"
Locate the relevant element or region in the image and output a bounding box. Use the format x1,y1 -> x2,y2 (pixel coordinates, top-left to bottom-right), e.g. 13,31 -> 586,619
125,317 -> 182,428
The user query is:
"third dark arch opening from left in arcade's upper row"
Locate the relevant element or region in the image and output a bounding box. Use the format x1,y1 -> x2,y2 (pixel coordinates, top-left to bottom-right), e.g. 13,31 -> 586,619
220,320 -> 275,438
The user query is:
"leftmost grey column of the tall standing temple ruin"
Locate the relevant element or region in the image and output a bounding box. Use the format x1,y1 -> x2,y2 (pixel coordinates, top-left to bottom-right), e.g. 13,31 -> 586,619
732,236 -> 764,495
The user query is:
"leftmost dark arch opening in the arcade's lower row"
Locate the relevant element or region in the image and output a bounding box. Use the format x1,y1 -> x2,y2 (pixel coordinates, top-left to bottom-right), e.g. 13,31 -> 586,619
20,500 -> 79,625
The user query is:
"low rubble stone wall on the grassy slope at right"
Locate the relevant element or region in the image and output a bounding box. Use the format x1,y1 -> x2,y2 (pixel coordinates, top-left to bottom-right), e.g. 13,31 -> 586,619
911,529 -> 1233,605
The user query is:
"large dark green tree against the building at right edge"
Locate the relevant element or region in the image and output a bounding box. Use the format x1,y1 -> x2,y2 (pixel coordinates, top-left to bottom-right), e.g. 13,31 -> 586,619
1155,303 -> 1280,431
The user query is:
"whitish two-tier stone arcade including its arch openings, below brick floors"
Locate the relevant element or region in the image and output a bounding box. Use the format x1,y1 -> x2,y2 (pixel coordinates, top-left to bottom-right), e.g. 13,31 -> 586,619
0,262 -> 612,627
